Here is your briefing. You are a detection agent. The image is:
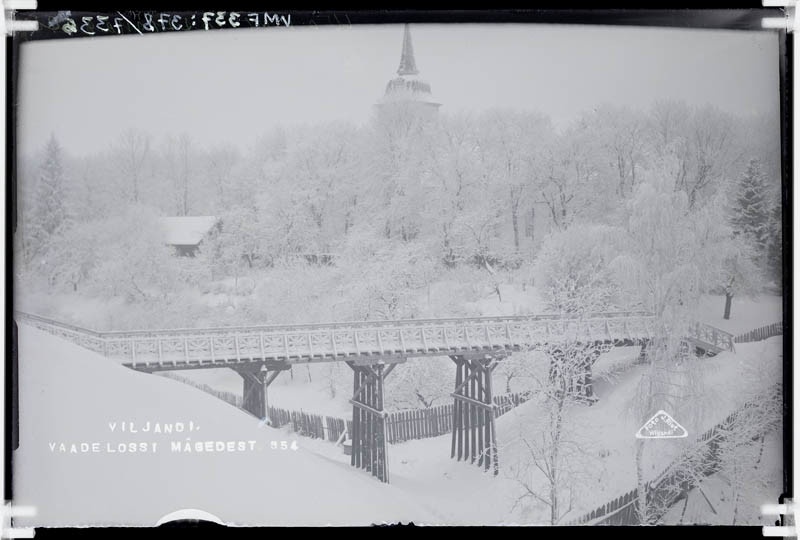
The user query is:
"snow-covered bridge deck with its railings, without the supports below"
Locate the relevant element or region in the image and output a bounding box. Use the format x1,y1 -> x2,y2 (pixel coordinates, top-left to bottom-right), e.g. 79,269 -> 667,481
16,312 -> 733,371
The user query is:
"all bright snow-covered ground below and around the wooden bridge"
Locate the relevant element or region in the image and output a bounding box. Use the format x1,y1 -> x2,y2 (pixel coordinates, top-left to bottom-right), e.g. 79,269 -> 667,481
13,292 -> 782,525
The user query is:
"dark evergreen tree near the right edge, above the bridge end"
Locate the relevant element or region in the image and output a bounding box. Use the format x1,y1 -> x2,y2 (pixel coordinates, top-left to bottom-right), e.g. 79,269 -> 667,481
730,159 -> 770,255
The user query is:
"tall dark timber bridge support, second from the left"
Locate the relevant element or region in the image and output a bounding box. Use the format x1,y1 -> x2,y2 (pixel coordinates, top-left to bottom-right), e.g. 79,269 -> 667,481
347,362 -> 397,483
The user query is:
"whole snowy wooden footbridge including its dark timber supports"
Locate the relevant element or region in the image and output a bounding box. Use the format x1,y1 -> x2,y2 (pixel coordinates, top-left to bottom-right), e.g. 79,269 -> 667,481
15,312 -> 734,482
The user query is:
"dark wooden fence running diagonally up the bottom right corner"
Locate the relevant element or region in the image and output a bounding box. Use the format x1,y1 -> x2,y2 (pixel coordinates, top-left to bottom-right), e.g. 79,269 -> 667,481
565,385 -> 781,525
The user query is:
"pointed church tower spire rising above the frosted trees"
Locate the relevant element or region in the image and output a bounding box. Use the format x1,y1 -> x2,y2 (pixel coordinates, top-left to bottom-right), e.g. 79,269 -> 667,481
375,24 -> 441,118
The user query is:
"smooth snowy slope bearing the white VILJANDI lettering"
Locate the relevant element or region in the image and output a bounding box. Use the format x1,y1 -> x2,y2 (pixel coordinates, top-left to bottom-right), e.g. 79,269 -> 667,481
13,325 -> 438,526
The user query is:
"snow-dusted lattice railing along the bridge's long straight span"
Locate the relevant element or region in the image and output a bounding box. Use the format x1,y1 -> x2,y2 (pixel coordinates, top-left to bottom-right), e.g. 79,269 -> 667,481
94,316 -> 654,364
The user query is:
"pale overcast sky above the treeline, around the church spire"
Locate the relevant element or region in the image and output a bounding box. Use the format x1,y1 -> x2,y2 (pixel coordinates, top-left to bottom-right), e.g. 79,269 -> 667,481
19,24 -> 778,154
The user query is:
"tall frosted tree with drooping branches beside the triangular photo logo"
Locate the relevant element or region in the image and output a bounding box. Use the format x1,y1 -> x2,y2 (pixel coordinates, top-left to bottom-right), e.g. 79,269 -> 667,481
612,168 -> 728,523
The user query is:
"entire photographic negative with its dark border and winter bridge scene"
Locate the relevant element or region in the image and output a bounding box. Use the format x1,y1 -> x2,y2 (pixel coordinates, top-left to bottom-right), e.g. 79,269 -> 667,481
4,6 -> 792,526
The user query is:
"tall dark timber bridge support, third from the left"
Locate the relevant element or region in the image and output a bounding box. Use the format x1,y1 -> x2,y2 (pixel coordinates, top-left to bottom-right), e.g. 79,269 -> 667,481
450,356 -> 499,475
